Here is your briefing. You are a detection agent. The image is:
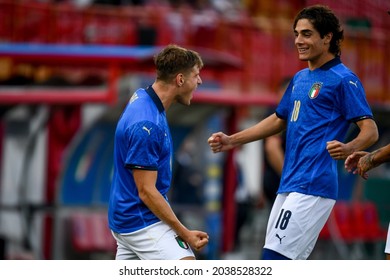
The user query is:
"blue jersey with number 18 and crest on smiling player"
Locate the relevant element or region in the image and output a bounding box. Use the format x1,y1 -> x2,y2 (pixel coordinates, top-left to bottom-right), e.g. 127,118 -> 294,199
276,57 -> 373,199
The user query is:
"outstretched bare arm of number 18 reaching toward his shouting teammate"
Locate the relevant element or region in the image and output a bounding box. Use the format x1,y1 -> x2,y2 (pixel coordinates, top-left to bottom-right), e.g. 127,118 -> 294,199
207,114 -> 286,153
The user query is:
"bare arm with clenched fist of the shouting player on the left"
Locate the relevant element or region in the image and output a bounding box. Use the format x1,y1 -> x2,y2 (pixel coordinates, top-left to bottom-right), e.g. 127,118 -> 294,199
132,169 -> 209,250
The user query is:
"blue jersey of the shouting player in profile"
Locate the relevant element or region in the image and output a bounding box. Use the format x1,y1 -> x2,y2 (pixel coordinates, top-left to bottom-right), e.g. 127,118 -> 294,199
108,86 -> 173,233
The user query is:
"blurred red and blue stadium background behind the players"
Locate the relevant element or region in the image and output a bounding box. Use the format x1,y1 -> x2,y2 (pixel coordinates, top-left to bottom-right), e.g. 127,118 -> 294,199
0,0 -> 390,259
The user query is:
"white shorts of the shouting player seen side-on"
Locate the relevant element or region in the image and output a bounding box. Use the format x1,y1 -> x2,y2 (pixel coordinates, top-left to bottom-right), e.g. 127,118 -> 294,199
112,222 -> 195,260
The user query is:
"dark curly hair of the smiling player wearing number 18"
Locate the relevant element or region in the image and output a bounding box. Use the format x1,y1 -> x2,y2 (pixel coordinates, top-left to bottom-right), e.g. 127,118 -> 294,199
293,5 -> 344,55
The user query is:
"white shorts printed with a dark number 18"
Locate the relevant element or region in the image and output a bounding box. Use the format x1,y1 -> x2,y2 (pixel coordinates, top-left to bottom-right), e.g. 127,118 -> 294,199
264,192 -> 336,260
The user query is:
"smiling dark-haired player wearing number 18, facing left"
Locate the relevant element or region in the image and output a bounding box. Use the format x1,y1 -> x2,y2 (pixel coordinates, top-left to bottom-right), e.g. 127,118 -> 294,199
208,5 -> 378,259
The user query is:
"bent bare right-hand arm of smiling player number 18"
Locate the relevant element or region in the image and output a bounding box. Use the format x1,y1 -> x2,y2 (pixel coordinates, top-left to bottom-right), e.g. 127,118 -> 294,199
326,119 -> 379,160
